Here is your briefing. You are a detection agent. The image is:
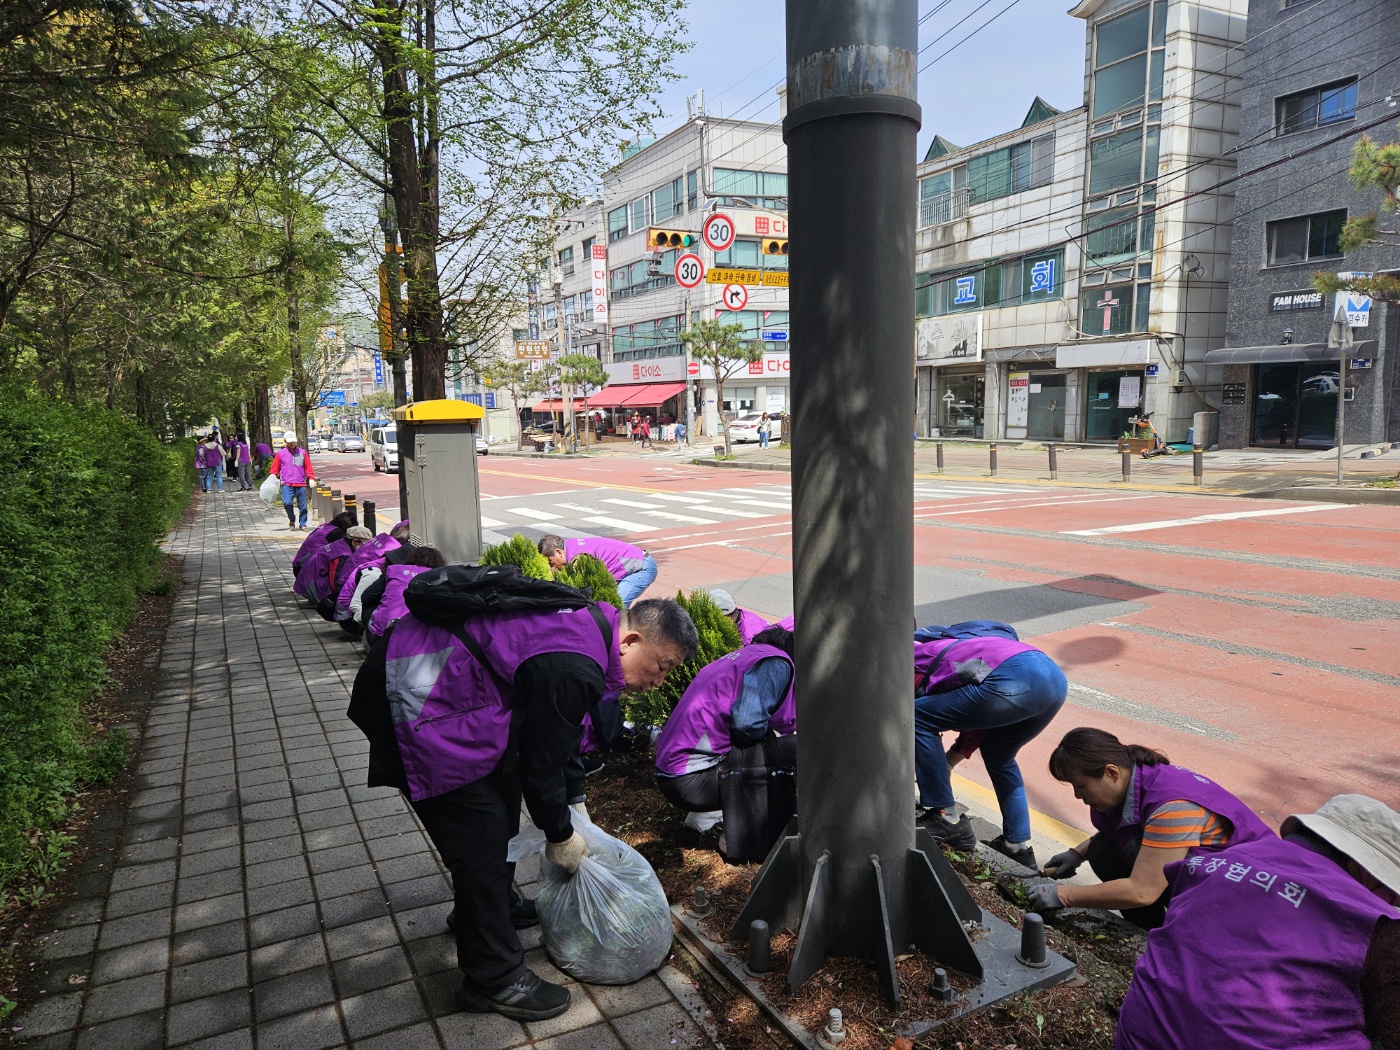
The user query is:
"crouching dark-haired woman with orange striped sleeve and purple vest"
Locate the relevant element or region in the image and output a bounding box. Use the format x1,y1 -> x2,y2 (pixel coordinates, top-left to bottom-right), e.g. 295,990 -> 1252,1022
1030,727 -> 1278,930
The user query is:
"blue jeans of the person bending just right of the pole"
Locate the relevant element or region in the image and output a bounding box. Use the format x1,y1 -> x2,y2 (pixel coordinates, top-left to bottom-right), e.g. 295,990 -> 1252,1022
914,652 -> 1070,843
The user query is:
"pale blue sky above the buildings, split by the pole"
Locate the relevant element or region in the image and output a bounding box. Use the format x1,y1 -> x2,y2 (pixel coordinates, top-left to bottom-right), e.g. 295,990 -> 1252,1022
657,0 -> 1084,157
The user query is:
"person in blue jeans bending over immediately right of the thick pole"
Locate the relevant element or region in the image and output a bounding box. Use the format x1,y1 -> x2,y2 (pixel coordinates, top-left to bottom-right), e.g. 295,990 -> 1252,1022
914,630 -> 1070,868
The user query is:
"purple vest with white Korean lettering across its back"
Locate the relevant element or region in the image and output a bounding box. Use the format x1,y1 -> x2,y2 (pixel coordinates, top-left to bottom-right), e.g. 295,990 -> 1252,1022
1114,839 -> 1400,1050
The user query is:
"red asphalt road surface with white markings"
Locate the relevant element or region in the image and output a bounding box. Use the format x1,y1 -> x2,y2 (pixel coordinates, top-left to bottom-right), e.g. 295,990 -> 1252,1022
319,456 -> 1400,827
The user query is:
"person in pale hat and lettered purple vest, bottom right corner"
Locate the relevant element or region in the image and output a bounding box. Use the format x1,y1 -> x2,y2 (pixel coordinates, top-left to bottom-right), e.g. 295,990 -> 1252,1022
1113,795 -> 1400,1050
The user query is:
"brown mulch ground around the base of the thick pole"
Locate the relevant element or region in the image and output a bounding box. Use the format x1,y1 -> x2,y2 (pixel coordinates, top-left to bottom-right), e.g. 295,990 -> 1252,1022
588,753 -> 1144,1050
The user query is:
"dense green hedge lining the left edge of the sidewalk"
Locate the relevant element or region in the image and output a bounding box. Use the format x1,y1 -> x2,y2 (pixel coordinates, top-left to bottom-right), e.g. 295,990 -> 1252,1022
0,391 -> 195,903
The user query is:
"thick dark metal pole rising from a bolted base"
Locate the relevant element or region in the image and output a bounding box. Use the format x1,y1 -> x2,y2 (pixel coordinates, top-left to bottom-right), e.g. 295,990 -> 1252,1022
783,0 -> 920,980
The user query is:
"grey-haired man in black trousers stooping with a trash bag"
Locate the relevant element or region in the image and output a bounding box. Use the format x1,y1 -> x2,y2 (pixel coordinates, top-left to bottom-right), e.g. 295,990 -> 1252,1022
349,596 -> 696,1021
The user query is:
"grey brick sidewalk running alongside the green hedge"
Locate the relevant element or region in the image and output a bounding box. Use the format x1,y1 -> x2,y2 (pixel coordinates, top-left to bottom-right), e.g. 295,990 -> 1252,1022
7,493 -> 715,1050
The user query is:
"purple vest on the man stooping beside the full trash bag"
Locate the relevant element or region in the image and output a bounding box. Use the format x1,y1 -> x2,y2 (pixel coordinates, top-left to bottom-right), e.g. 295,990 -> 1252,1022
385,605 -> 626,801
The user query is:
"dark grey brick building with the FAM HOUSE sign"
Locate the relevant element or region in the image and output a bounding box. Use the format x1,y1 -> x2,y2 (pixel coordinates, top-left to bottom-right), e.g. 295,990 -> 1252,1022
1211,0 -> 1400,448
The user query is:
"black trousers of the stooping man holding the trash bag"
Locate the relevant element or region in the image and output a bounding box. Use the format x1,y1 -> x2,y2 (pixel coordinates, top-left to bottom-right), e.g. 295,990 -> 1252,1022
413,773 -> 526,993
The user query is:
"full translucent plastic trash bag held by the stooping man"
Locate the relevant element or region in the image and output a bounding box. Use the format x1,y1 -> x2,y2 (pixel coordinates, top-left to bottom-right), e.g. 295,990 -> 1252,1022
508,809 -> 672,984
